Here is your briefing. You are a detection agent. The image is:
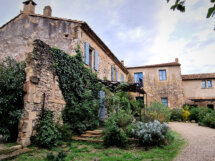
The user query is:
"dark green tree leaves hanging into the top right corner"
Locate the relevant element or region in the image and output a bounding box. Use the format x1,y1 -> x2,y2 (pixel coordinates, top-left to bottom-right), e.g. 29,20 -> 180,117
167,0 -> 215,18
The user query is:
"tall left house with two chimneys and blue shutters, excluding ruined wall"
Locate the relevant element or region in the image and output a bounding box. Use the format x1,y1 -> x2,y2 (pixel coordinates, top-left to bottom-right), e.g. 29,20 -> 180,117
0,0 -> 128,82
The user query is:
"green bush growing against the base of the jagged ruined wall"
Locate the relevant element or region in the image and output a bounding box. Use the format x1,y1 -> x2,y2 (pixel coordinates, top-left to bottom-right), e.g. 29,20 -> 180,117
31,109 -> 62,149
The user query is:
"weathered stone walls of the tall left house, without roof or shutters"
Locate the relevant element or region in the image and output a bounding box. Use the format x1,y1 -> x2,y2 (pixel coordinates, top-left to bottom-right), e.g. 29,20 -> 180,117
0,13 -> 127,81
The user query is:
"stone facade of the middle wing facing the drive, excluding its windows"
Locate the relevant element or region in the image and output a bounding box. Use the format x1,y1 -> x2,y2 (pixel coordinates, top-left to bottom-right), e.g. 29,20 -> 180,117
128,60 -> 184,108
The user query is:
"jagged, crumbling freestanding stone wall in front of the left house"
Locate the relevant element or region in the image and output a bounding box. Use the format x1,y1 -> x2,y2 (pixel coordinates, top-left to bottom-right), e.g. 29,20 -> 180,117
18,40 -> 66,146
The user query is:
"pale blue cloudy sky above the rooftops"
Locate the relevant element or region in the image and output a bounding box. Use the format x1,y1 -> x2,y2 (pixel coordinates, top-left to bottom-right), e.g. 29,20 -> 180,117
0,0 -> 215,74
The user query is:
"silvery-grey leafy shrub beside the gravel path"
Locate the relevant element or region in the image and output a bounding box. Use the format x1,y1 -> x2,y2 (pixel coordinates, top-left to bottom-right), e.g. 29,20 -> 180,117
133,120 -> 169,146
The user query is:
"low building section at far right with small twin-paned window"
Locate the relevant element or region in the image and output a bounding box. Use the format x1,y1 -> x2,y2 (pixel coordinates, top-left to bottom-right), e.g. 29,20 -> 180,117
182,73 -> 215,109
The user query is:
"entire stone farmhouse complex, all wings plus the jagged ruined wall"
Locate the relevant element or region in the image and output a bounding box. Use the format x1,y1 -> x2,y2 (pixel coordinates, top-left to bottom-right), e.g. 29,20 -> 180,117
0,0 -> 215,146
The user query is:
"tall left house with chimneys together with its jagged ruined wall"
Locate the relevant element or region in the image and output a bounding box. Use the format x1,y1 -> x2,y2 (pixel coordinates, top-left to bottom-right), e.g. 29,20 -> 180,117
0,0 -> 128,146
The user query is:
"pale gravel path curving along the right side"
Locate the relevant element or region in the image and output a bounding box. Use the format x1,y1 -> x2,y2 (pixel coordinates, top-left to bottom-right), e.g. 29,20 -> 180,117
169,122 -> 215,161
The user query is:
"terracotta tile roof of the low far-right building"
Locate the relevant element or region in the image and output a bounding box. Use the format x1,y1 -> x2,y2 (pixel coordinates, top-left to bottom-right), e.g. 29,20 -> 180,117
182,73 -> 215,80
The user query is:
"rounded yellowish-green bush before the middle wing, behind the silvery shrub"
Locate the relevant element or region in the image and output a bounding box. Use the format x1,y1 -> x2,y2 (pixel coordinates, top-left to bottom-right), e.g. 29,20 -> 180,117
144,102 -> 171,123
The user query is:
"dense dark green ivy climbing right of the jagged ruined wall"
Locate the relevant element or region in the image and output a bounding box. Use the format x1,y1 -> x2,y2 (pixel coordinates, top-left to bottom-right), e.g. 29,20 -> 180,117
52,48 -> 102,133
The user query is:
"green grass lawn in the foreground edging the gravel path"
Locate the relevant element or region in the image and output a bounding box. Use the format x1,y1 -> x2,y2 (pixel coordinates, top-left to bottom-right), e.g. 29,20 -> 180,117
14,132 -> 185,161
